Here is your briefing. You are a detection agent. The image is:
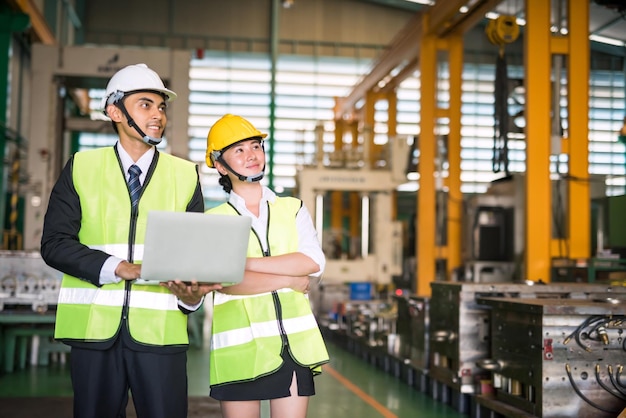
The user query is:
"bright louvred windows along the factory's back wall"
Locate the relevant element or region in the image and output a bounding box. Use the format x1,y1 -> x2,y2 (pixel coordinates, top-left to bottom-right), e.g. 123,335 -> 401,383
79,51 -> 626,202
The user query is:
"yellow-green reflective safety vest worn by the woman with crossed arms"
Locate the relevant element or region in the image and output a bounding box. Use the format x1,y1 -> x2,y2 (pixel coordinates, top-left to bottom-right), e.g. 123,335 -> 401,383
207,197 -> 329,386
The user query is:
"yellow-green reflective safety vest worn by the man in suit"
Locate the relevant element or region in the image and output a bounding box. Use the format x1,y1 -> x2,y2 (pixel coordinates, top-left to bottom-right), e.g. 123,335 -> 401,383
55,147 -> 198,346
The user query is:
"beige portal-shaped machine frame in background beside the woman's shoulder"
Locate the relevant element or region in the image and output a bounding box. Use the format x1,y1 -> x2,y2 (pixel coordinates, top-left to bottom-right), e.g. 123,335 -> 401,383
297,132 -> 408,284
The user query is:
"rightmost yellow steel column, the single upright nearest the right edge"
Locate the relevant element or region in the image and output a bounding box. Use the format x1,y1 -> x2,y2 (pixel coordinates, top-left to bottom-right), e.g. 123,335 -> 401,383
567,0 -> 591,258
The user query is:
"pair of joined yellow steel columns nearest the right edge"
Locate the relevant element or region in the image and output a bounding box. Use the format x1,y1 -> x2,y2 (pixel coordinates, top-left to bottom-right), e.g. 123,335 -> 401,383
524,0 -> 591,282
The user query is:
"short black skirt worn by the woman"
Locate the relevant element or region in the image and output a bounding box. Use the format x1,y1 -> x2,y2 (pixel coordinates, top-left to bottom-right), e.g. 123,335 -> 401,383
209,350 -> 315,401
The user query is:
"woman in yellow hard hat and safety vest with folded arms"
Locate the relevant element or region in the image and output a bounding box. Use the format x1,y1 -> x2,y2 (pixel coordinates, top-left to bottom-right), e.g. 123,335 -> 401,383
206,114 -> 329,418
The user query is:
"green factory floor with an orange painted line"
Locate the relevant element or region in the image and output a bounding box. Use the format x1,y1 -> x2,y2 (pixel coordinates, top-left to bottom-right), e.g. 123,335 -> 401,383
0,342 -> 467,418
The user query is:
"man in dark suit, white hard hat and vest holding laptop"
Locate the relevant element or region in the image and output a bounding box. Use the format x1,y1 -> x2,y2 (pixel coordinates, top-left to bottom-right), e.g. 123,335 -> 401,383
41,64 -> 221,418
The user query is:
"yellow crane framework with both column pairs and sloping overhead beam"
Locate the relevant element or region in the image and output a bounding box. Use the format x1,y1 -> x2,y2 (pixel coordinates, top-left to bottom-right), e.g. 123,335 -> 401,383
335,0 -> 590,296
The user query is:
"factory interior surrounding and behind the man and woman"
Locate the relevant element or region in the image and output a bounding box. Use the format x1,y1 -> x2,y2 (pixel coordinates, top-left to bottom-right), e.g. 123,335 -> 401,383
0,0 -> 626,418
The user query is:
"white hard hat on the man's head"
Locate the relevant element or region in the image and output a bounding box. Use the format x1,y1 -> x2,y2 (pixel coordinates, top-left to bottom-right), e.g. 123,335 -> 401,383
102,64 -> 176,114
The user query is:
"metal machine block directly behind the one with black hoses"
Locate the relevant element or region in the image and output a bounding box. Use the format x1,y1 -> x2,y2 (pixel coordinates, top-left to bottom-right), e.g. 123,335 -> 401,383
429,282 -> 626,416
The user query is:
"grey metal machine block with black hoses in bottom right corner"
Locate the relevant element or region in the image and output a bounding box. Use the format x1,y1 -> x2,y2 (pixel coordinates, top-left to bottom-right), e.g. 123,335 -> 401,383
479,293 -> 626,418
